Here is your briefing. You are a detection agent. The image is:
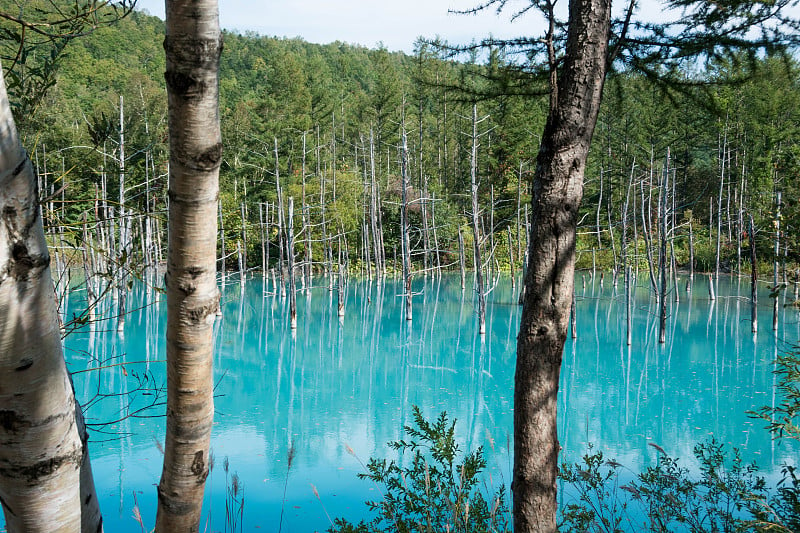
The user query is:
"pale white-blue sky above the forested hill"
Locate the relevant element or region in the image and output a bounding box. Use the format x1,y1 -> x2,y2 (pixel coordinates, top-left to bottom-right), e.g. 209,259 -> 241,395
133,0 -> 541,53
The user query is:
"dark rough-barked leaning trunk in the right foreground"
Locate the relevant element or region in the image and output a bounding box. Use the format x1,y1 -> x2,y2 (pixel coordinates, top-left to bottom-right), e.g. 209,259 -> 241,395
512,0 -> 611,533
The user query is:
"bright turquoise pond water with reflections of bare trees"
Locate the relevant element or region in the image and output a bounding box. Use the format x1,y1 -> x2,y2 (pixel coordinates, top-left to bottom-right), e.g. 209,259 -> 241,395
29,273 -> 800,532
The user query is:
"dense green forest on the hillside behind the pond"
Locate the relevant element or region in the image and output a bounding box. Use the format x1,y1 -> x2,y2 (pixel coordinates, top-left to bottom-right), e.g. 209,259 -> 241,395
10,7 -> 800,278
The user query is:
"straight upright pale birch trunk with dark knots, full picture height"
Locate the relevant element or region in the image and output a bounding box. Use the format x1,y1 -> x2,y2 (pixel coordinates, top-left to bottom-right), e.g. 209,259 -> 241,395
156,0 -> 222,533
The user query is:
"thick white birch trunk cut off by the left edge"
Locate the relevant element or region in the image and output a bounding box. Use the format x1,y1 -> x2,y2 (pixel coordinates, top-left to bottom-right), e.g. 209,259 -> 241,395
0,58 -> 103,533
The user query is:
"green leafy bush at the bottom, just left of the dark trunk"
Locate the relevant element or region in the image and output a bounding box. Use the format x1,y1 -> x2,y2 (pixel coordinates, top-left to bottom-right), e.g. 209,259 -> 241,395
328,406 -> 510,533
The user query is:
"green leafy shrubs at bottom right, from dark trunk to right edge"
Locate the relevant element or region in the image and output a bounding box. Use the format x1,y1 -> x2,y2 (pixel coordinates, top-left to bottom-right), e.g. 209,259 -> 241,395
560,350 -> 800,533
